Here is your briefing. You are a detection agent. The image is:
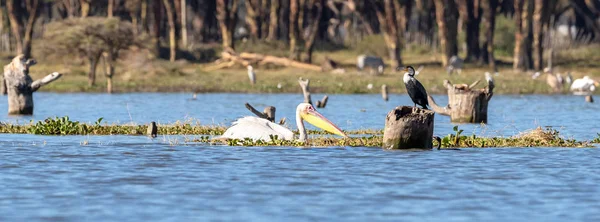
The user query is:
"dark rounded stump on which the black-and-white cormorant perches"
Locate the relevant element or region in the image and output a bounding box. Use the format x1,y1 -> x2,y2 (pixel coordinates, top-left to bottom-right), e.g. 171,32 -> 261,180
383,106 -> 435,149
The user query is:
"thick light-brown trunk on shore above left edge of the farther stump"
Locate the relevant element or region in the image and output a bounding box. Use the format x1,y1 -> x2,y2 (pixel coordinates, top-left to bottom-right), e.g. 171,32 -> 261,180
433,0 -> 458,66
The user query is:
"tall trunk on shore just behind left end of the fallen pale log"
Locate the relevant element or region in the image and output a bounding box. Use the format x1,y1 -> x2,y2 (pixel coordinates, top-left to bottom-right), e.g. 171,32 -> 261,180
217,0 -> 238,49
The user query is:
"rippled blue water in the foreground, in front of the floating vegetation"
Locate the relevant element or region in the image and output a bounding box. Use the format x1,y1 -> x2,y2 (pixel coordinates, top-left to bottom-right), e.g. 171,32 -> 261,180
0,135 -> 600,221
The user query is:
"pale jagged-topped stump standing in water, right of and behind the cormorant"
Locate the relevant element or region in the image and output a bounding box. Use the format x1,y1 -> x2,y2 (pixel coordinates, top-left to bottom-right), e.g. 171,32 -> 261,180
427,80 -> 494,123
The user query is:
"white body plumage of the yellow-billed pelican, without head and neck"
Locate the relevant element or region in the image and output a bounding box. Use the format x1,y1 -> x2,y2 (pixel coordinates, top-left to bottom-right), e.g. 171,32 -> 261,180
221,116 -> 294,141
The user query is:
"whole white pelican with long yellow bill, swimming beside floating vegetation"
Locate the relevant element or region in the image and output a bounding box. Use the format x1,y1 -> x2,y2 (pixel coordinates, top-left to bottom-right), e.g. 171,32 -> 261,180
218,103 -> 348,142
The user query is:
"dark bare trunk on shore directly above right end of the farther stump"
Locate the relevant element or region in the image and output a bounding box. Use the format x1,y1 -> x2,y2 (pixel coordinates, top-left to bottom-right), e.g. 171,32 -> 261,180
481,0 -> 498,70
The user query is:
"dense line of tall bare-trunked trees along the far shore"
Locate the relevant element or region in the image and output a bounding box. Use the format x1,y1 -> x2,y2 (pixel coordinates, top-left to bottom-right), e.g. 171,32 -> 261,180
0,0 -> 600,70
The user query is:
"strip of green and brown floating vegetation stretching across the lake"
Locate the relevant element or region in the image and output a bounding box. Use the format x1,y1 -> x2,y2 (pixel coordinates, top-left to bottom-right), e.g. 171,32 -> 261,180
0,117 -> 600,148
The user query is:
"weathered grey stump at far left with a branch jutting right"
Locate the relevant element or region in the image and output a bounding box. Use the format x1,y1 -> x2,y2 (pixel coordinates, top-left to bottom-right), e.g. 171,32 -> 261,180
4,55 -> 62,115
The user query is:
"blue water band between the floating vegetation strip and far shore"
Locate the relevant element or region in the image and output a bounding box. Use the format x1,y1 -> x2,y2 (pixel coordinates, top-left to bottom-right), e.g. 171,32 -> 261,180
0,93 -> 600,140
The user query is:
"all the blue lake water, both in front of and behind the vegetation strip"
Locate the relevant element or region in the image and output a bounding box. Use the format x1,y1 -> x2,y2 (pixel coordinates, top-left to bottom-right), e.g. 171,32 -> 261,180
0,93 -> 600,221
